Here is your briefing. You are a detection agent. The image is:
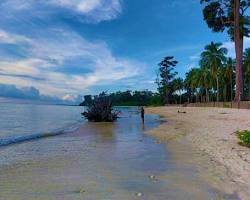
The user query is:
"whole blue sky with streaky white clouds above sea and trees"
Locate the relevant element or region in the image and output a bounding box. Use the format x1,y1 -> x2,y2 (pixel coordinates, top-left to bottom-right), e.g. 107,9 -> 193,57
0,0 -> 250,102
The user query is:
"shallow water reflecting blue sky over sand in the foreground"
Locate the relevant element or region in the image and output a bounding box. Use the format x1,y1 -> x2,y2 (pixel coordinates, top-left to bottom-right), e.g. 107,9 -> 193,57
0,108 -> 237,200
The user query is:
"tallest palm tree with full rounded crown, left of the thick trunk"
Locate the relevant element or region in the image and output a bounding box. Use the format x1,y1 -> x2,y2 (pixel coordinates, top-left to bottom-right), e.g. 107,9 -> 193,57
200,42 -> 227,102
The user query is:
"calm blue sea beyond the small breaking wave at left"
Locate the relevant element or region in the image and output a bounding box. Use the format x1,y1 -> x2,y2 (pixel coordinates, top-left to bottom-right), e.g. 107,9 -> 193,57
0,103 -> 84,146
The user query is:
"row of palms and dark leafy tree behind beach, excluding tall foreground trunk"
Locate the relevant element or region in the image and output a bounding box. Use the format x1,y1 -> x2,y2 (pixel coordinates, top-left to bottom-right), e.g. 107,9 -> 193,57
156,45 -> 250,104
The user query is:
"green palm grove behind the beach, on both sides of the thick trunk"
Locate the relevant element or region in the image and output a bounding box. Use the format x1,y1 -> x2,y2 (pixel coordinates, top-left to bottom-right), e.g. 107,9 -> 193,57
182,45 -> 250,102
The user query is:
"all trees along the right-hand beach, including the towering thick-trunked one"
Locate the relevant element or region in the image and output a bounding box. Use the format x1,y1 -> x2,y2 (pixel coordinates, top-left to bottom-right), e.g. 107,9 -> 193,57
156,0 -> 250,103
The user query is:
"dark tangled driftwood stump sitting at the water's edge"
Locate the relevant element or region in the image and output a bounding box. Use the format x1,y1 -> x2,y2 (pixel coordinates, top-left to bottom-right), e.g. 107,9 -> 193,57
82,92 -> 119,122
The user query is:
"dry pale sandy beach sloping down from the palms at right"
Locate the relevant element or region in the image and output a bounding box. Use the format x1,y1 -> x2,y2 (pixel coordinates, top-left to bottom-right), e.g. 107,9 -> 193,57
147,107 -> 250,199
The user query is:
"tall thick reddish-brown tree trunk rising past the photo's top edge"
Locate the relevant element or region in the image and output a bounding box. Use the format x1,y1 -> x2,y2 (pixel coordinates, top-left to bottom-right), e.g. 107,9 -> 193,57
234,0 -> 243,102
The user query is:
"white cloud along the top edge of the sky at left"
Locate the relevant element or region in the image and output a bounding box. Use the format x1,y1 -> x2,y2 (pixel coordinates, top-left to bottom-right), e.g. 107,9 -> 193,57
0,0 -> 122,23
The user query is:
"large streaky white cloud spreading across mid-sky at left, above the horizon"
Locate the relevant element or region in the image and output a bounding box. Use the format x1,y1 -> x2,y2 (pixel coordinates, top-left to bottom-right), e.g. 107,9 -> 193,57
0,29 -> 144,96
